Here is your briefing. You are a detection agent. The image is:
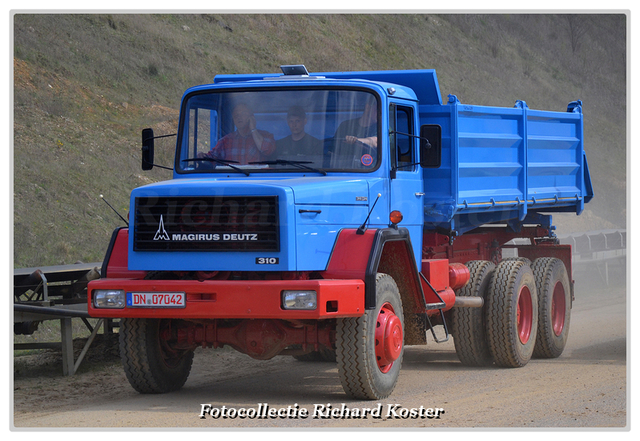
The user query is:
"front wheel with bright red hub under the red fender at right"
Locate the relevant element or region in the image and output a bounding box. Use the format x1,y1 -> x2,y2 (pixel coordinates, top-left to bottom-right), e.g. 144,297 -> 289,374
336,273 -> 404,400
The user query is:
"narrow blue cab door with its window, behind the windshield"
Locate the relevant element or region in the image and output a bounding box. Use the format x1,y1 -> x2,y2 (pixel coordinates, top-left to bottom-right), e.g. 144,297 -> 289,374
388,102 -> 424,267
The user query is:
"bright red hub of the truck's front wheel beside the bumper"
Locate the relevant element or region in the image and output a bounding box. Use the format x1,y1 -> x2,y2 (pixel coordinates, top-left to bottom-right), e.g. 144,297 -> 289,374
375,303 -> 403,373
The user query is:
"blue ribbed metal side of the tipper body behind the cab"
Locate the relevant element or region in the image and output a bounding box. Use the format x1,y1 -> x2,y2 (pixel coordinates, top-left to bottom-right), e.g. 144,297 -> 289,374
420,95 -> 593,233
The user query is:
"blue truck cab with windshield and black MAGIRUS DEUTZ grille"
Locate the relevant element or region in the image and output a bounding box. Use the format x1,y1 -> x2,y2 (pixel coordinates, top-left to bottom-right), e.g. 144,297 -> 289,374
129,67 -> 439,271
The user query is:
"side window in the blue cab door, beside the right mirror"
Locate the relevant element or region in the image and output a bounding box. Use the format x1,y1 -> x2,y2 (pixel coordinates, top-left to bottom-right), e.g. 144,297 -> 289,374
389,104 -> 415,171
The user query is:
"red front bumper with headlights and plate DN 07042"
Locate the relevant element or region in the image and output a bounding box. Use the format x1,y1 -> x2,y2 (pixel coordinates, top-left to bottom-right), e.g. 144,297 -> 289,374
88,278 -> 364,320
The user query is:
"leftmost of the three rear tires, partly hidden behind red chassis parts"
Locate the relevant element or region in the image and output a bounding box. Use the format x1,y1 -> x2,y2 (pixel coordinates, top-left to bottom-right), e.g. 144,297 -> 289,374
451,260 -> 496,366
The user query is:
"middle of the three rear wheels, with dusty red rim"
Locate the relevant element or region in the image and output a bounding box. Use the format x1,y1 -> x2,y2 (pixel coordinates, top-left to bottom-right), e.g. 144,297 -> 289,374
486,260 -> 538,367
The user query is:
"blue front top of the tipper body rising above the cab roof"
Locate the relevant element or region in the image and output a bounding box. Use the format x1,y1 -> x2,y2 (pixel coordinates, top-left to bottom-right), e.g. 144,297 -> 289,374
213,69 -> 442,105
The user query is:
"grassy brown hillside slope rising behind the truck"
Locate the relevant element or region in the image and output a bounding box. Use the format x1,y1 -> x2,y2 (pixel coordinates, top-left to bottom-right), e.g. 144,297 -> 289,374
13,14 -> 628,267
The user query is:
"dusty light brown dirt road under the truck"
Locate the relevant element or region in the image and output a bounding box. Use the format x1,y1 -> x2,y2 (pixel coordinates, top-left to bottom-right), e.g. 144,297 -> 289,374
13,278 -> 628,429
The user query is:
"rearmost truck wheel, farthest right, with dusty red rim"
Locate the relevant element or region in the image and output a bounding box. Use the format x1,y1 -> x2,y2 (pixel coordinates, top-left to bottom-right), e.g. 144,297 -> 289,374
531,257 -> 572,358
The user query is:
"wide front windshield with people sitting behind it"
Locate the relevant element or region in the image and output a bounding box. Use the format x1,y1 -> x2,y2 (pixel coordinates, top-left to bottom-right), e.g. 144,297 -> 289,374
176,89 -> 380,175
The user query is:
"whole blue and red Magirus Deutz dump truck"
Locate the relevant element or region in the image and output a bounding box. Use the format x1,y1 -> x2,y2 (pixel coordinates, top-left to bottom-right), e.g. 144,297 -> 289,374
88,65 -> 593,399
